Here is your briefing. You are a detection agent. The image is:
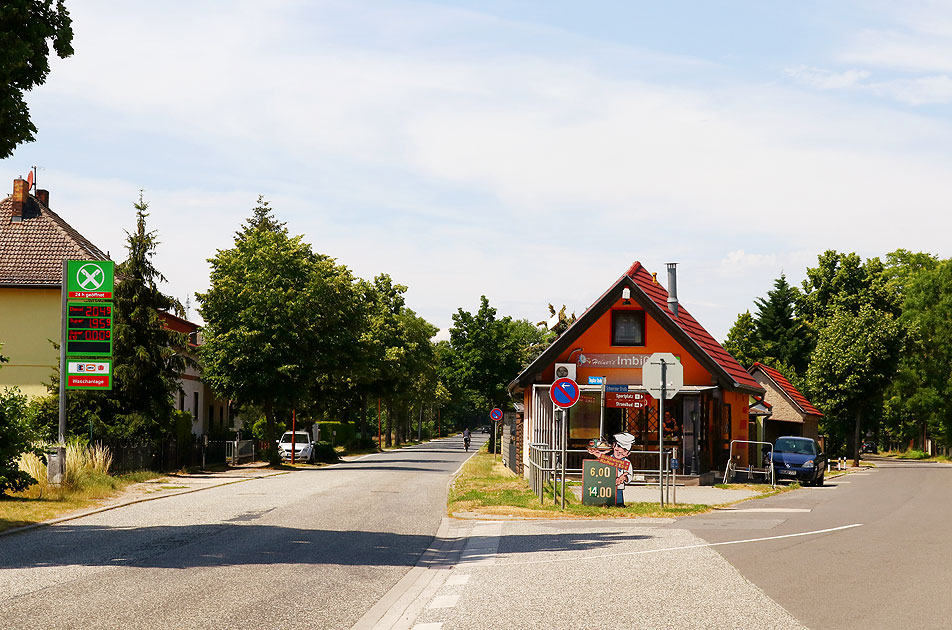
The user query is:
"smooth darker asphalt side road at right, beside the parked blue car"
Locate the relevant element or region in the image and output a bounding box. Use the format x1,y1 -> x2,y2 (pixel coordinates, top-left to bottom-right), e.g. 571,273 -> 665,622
678,458 -> 952,630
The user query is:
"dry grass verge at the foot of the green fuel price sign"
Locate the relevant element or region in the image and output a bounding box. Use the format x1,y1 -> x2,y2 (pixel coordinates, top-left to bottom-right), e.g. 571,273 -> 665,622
0,471 -> 162,532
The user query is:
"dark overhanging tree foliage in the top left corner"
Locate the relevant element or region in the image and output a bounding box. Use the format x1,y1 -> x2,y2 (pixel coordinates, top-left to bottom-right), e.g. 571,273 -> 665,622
0,0 -> 73,159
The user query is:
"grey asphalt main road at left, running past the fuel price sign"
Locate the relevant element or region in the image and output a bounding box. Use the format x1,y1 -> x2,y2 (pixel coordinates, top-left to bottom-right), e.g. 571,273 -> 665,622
0,434 -> 486,630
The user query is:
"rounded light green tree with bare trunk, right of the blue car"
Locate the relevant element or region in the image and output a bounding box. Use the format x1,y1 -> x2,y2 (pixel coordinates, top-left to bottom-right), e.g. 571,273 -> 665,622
807,304 -> 902,466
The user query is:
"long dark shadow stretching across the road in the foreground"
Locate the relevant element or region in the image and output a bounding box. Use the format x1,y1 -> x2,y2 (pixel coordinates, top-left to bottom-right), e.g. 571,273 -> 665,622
0,524 -> 648,569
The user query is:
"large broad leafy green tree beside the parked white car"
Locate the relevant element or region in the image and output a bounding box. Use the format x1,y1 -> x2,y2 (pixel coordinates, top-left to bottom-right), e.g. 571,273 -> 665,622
197,197 -> 356,461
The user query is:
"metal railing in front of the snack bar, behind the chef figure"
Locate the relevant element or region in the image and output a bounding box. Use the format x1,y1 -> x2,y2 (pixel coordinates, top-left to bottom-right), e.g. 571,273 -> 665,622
528,443 -> 677,509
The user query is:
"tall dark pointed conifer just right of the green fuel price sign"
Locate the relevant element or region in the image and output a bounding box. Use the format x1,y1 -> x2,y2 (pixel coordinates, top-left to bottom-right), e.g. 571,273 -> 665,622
109,193 -> 187,439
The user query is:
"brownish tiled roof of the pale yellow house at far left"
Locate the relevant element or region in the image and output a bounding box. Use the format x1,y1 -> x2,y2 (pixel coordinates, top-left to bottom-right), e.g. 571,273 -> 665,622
0,190 -> 107,287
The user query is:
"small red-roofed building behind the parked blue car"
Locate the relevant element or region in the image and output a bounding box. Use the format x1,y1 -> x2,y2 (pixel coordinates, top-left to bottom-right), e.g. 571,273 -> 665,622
749,363 -> 823,443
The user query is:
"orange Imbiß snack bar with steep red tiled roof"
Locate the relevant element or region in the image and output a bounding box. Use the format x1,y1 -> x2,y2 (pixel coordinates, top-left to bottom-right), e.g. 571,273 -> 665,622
509,262 -> 764,483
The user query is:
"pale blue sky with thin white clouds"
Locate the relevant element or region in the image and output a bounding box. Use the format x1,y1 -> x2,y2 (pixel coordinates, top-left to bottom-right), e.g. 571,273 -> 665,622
0,0 -> 952,341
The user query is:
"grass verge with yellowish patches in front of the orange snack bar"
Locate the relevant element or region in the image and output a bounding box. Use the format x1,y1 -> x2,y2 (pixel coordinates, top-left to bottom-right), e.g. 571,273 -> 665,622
447,452 -> 711,518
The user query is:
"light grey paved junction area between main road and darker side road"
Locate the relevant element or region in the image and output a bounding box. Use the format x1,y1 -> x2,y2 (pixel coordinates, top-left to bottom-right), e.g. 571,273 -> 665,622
353,519 -> 803,630
